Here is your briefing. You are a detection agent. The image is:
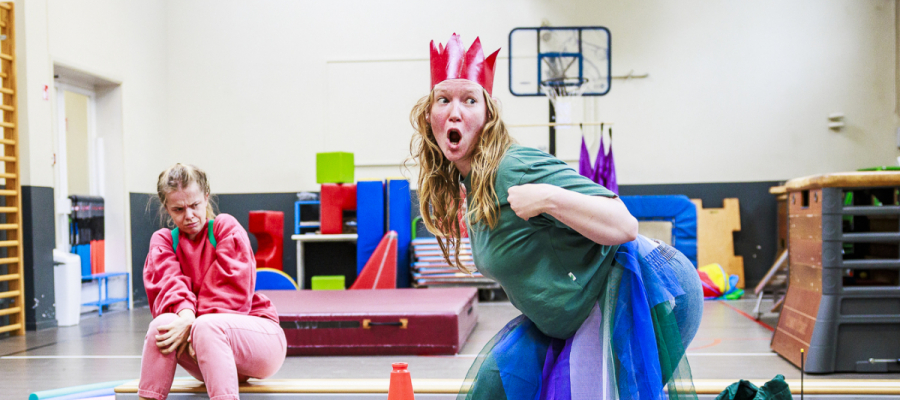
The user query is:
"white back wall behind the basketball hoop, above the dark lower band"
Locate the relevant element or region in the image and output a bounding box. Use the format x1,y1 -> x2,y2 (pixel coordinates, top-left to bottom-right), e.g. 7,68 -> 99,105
162,0 -> 900,193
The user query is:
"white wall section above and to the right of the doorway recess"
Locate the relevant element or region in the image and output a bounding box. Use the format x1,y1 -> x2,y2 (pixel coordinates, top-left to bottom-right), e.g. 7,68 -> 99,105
46,0 -> 168,191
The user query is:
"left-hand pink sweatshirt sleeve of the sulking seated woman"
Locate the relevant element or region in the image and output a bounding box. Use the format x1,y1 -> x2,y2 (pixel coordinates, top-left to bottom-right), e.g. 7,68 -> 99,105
144,229 -> 197,318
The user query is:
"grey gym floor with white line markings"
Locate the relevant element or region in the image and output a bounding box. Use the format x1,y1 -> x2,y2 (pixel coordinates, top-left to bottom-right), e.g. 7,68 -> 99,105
0,299 -> 900,399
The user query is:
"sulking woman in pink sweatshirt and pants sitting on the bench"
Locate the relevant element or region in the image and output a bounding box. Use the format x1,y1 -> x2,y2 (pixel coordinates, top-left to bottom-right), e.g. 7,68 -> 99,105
138,164 -> 287,400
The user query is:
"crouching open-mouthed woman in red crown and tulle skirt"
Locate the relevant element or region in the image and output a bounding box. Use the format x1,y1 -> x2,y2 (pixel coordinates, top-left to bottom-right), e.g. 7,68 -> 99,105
410,34 -> 703,399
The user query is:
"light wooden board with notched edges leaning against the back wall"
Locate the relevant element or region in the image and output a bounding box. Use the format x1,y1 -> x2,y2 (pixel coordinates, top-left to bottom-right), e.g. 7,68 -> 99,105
691,199 -> 744,289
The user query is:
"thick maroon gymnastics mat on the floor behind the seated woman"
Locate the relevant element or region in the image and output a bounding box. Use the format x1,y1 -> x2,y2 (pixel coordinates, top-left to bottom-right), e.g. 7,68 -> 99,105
260,288 -> 478,355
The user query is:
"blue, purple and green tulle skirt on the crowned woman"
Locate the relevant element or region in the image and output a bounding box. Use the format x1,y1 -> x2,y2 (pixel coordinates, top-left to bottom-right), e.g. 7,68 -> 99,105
459,238 -> 702,400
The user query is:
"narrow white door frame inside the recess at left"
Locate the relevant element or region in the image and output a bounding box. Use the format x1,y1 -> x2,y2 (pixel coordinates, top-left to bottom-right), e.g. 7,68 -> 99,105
53,81 -> 104,252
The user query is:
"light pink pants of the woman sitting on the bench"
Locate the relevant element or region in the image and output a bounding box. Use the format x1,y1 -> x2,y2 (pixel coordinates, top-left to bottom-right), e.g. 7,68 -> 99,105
138,313 -> 287,400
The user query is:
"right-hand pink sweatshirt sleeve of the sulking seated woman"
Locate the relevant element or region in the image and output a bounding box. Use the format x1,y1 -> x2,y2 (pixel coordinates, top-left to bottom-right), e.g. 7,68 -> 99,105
197,214 -> 256,315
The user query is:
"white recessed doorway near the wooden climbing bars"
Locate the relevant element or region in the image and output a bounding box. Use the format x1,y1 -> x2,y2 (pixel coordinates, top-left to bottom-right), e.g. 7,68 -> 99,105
53,62 -> 131,310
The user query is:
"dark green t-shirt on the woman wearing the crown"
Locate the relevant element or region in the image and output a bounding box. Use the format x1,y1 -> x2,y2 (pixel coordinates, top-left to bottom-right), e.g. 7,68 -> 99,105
463,145 -> 618,339
